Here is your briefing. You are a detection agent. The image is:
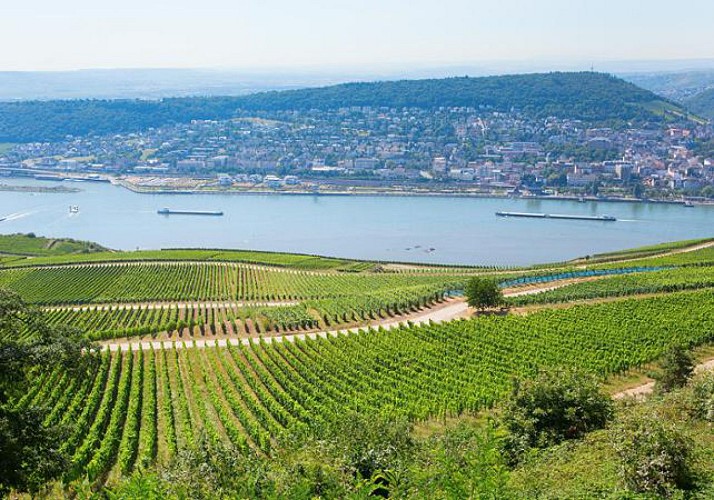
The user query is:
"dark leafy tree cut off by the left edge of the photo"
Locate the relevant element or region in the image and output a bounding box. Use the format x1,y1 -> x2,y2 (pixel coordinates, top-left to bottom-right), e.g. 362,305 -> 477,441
0,289 -> 95,495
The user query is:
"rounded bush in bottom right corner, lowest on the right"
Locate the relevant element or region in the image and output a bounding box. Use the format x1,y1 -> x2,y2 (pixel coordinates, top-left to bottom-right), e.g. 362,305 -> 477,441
612,408 -> 692,497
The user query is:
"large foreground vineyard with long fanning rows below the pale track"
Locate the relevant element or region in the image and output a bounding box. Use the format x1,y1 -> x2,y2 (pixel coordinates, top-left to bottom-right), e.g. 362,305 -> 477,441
19,291 -> 714,482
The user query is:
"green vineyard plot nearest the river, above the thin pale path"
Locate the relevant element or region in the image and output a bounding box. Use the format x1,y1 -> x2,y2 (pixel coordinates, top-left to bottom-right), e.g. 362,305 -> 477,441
0,262 -> 465,305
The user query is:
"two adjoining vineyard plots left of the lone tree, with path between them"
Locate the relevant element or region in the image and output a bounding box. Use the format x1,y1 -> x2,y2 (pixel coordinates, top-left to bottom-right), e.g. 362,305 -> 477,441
0,262 -> 468,340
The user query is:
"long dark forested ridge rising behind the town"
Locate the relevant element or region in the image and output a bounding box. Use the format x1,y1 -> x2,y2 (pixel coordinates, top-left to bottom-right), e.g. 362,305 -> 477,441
0,72 -> 678,142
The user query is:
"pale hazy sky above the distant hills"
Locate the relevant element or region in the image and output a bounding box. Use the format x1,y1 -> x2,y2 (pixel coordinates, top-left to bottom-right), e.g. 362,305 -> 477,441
5,0 -> 714,71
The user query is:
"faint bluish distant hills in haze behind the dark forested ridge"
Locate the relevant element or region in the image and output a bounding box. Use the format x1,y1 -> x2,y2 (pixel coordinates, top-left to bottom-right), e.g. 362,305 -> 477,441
0,60 -> 714,101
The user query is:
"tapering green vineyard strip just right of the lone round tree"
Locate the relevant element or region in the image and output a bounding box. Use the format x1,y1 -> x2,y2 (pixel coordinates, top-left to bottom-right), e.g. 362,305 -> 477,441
508,266 -> 714,306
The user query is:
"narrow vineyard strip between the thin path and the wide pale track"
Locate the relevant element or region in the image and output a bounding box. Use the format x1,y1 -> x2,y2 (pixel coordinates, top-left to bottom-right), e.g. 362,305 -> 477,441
33,285 -> 444,340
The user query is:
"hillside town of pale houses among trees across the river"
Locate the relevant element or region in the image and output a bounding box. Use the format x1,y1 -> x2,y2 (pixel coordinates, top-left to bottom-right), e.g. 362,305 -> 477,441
0,107 -> 714,200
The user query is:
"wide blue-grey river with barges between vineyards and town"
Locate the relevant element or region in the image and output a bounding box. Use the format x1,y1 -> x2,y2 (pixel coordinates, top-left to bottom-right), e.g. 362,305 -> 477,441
0,179 -> 714,265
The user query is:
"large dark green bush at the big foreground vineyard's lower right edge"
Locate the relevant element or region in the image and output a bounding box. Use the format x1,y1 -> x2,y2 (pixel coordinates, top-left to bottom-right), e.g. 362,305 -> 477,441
501,370 -> 613,462
